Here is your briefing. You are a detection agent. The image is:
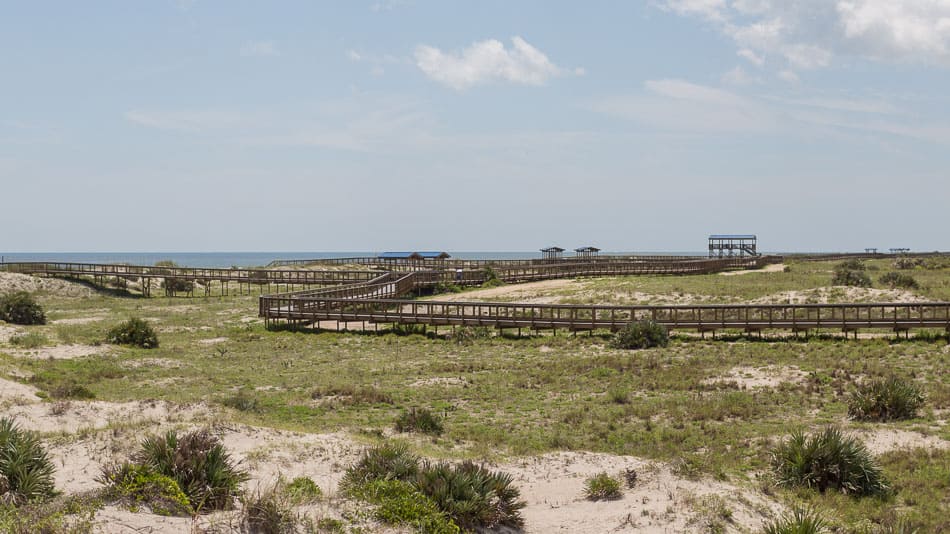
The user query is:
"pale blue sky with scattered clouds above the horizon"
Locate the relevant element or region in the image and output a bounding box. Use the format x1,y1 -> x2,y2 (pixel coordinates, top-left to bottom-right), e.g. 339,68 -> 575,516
0,0 -> 950,252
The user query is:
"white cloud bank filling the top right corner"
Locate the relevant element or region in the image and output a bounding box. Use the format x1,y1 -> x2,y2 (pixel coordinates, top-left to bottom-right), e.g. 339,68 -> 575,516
658,0 -> 950,78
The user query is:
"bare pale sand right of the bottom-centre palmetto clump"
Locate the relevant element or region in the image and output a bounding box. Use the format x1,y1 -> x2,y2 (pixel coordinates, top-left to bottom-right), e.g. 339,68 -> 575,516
499,452 -> 779,533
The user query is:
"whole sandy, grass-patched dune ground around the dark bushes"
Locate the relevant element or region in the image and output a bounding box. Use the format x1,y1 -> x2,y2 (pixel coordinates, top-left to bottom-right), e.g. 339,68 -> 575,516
0,261 -> 950,533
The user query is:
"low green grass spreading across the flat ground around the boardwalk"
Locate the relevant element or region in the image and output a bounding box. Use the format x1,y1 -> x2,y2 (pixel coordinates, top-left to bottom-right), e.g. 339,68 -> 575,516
0,261 -> 950,532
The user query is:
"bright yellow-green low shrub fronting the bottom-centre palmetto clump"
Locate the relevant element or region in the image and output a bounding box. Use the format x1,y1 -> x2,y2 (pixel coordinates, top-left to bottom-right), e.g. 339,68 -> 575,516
349,480 -> 459,534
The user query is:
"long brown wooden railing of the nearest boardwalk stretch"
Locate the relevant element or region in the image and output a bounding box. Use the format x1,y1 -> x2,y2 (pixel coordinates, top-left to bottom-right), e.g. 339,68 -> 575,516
260,296 -> 950,332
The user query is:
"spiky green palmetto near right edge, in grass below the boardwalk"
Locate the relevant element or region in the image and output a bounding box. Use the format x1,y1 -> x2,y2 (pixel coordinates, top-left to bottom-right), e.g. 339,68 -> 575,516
848,377 -> 924,421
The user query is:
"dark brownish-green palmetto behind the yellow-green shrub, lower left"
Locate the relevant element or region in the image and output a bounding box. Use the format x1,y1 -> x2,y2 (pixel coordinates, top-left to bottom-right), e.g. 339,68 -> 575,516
133,429 -> 248,511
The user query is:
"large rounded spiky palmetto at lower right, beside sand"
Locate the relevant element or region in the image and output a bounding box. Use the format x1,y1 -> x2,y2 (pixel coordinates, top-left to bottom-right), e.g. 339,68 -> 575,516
772,426 -> 888,496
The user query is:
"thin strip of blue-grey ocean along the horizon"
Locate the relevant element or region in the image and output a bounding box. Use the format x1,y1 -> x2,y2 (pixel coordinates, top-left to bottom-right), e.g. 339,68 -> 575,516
0,251 -> 706,268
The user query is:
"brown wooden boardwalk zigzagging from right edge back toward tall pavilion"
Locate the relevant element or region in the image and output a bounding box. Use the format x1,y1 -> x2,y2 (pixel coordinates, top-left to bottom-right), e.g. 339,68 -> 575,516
259,258 -> 950,338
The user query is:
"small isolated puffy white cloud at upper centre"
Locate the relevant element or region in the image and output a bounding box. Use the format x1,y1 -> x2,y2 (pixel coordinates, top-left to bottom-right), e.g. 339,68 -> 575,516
415,37 -> 565,91
